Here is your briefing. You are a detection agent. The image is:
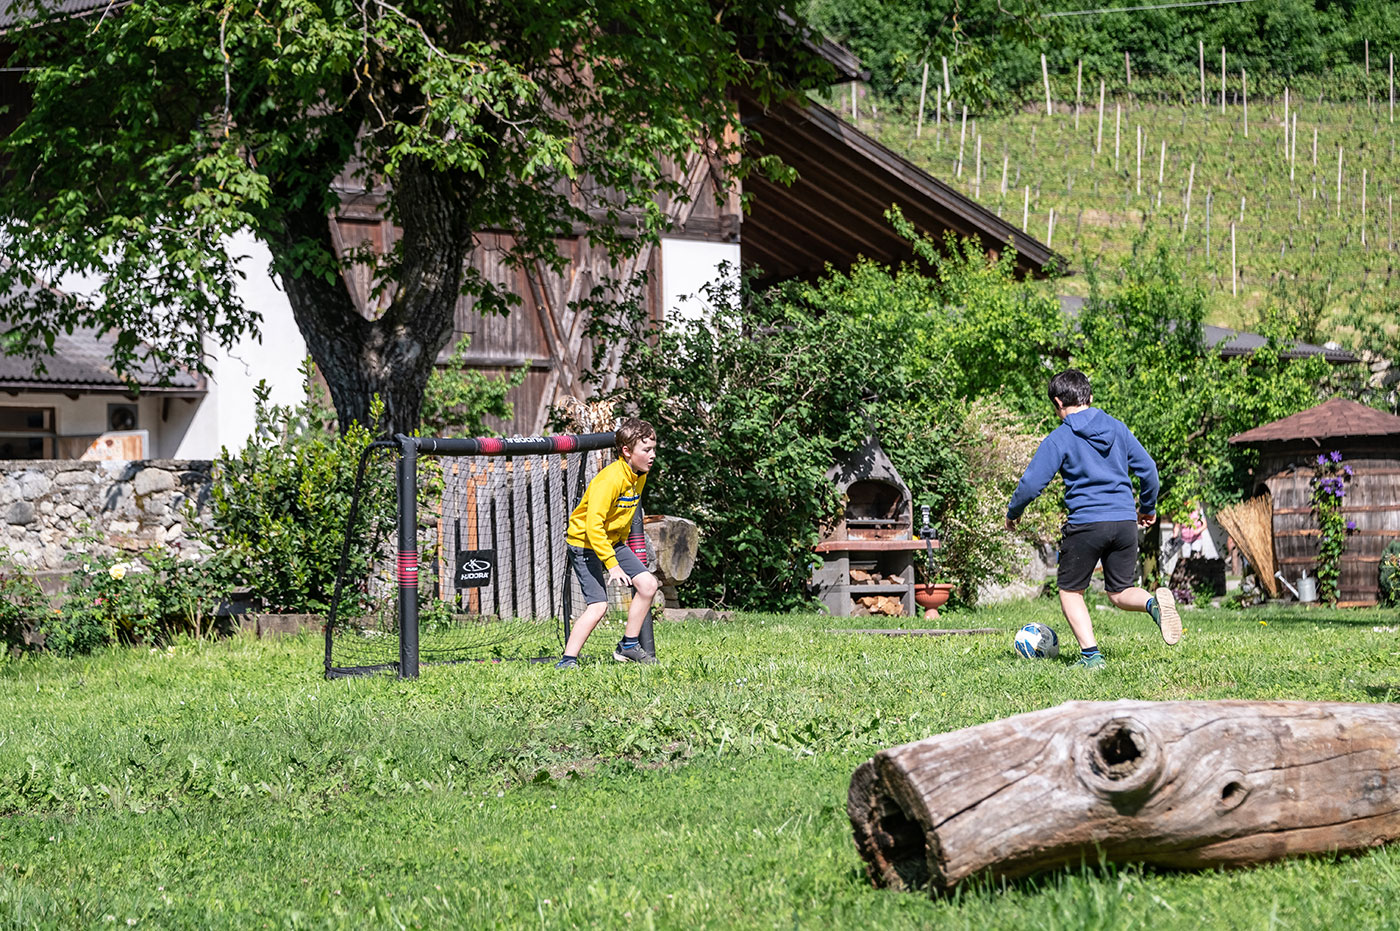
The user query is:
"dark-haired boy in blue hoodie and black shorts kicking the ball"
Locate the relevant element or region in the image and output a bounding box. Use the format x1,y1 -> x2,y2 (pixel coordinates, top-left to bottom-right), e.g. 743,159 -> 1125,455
1007,368 -> 1182,669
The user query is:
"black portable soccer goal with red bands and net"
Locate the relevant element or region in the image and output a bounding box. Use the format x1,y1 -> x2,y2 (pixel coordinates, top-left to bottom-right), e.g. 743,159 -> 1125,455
325,433 -> 630,679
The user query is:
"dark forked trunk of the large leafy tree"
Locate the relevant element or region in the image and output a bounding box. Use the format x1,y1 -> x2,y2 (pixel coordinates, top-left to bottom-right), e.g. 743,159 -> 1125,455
274,156 -> 472,435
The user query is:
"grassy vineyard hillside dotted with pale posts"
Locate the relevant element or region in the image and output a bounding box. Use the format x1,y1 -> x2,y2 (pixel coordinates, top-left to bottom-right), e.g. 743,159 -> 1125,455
847,92 -> 1400,352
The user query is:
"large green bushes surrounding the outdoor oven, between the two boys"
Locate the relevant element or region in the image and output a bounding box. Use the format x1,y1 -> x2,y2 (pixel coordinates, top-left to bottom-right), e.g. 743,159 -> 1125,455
591,214 -> 1064,610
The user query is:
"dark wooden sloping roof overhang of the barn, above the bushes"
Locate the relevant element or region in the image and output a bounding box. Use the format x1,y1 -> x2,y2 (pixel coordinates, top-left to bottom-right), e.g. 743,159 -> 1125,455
739,97 -> 1068,280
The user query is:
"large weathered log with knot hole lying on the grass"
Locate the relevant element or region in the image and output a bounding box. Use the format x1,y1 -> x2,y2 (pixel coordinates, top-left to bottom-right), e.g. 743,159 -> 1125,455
847,701 -> 1400,895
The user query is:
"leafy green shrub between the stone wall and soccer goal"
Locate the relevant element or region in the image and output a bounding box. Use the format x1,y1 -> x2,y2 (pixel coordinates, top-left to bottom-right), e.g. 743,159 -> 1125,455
203,361 -> 393,613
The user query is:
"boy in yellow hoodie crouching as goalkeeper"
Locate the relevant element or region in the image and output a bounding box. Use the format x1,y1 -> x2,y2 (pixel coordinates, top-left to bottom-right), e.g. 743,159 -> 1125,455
554,417 -> 658,669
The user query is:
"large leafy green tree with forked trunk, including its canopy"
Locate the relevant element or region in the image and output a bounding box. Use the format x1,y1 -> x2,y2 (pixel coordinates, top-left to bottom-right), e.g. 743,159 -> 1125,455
0,0 -> 825,430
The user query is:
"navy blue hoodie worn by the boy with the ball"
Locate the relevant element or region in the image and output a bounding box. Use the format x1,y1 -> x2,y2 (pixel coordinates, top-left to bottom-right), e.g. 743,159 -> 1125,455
1007,407 -> 1158,524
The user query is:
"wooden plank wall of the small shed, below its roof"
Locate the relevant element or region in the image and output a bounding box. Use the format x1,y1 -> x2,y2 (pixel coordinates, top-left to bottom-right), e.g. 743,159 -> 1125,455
1256,438 -> 1400,603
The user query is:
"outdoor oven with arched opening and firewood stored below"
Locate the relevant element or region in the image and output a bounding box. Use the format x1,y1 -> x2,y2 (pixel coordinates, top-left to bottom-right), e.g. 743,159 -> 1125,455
812,435 -> 937,617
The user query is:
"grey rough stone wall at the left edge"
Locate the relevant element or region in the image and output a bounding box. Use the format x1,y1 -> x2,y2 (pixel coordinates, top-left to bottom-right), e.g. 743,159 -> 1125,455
0,459 -> 213,571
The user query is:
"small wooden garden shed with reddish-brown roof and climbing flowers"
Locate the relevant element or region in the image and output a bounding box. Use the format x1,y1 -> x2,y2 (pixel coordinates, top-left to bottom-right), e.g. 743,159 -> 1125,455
1231,398 -> 1400,606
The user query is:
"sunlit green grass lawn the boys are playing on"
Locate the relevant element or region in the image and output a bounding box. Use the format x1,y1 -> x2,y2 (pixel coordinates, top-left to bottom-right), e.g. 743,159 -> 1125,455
0,601 -> 1400,930
